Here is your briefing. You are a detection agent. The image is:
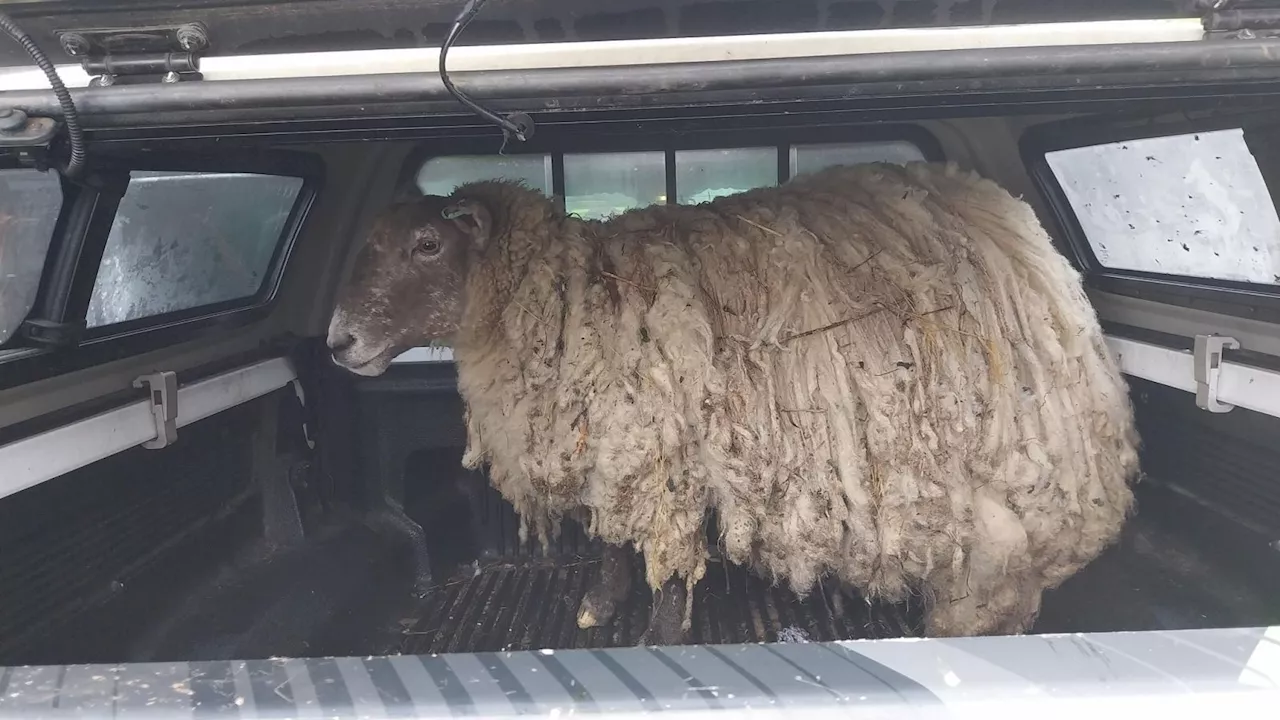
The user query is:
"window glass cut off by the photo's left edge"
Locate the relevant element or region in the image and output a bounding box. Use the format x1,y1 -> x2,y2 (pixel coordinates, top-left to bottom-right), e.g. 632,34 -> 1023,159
0,169 -> 63,345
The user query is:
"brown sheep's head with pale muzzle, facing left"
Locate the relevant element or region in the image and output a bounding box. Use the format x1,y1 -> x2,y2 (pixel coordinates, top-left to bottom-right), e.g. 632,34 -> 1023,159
329,196 -> 490,375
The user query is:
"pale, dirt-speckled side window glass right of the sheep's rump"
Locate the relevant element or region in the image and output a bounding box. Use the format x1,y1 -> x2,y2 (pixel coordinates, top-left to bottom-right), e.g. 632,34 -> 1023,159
1046,129 -> 1280,284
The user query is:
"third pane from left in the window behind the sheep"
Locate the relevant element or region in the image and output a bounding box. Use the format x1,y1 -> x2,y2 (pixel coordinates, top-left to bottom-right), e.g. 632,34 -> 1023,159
676,147 -> 778,205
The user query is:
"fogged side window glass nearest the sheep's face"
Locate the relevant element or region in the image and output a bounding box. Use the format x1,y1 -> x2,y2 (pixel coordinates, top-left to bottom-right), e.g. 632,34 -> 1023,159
87,172 -> 302,328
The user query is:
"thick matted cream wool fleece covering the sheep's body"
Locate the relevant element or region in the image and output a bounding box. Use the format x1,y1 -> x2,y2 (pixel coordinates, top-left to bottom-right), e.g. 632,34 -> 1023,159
454,164 -> 1138,635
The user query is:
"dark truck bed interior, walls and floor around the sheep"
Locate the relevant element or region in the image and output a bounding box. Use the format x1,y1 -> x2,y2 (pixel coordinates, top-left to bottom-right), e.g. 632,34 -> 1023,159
0,348 -> 1280,665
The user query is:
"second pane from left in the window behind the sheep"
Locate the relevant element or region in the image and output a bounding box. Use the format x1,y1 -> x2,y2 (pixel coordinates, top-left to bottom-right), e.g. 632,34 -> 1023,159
564,152 -> 667,219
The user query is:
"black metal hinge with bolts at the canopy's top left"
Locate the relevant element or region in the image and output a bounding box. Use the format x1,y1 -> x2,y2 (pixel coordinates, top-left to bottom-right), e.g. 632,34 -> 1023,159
58,22 -> 210,87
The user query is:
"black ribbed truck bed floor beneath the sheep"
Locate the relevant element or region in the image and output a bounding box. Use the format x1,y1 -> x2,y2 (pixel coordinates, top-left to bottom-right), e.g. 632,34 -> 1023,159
12,474 -> 1280,665
